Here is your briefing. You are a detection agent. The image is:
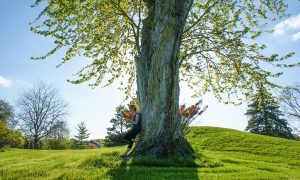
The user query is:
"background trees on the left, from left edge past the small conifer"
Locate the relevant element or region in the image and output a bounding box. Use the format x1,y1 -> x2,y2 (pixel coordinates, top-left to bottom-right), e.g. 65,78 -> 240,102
0,82 -> 100,149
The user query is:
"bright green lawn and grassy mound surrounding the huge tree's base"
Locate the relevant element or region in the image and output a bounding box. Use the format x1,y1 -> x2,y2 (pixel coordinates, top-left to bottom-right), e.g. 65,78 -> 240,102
0,127 -> 300,180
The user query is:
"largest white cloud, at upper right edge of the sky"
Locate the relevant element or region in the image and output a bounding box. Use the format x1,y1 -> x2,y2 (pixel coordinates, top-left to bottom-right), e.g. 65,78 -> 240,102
274,13 -> 300,35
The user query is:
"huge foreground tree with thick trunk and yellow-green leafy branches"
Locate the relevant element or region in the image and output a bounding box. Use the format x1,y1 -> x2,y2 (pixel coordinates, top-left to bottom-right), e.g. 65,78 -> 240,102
32,0 -> 293,157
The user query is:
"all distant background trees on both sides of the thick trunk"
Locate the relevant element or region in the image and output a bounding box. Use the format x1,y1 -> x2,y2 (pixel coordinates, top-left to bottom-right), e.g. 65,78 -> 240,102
0,83 -> 300,149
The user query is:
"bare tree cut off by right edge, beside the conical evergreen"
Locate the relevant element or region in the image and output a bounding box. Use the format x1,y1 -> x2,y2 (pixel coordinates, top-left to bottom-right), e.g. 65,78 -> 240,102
281,85 -> 300,134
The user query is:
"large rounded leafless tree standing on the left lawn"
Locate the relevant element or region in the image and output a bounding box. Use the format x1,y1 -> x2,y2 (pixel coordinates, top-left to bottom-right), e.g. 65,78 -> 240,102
17,83 -> 68,148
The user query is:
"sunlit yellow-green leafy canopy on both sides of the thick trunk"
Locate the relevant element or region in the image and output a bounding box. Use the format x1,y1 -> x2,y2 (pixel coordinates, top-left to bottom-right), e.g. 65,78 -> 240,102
31,0 -> 298,102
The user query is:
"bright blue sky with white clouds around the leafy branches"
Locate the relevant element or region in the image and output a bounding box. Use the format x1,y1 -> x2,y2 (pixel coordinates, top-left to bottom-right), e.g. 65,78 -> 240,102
0,0 -> 300,138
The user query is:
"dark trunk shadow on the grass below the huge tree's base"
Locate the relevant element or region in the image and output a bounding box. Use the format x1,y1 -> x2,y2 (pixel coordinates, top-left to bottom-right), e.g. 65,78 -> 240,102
107,158 -> 199,179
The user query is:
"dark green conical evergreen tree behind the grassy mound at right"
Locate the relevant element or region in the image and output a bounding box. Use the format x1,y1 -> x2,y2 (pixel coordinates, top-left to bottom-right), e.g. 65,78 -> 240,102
246,87 -> 293,139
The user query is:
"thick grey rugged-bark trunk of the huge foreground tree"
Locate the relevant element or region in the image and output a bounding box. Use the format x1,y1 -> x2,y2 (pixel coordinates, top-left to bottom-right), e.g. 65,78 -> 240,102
132,0 -> 193,158
